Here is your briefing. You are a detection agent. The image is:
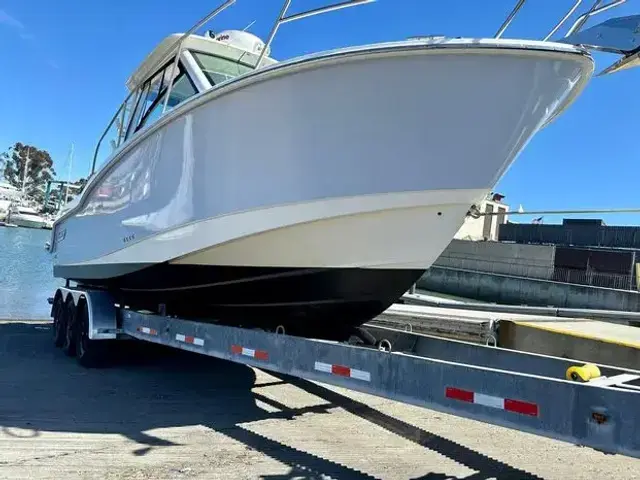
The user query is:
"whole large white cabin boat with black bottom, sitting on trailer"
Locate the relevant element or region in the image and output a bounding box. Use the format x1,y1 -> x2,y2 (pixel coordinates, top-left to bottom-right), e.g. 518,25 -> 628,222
47,0 -> 635,335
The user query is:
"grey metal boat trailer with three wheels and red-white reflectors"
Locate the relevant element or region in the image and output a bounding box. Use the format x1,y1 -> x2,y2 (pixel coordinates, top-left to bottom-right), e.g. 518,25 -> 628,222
49,286 -> 640,458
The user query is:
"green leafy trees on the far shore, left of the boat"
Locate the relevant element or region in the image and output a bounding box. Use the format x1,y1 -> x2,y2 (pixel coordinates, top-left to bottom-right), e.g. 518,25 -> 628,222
0,142 -> 87,208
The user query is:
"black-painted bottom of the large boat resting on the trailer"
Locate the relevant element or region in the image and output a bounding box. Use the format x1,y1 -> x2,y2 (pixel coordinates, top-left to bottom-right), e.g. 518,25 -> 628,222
72,264 -> 424,337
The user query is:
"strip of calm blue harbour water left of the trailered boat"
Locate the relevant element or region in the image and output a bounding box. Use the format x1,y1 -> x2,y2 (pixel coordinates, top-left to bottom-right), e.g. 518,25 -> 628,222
0,227 -> 64,319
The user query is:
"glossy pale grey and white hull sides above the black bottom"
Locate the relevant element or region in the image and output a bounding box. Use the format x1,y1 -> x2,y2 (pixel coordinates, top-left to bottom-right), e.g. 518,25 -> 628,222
52,42 -> 593,328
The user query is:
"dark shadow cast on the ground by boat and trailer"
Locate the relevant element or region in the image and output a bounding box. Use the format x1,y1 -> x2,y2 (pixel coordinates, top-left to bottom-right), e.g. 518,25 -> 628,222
0,322 -> 537,480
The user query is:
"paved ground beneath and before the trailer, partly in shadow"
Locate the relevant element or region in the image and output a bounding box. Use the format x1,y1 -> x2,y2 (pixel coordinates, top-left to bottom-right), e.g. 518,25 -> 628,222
0,322 -> 640,480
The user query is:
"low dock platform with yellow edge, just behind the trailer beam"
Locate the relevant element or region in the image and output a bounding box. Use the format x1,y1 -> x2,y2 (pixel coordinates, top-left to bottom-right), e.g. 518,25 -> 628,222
384,294 -> 640,370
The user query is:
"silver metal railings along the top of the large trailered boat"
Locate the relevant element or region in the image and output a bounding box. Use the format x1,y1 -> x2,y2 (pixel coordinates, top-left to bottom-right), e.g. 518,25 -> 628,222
90,0 -> 627,176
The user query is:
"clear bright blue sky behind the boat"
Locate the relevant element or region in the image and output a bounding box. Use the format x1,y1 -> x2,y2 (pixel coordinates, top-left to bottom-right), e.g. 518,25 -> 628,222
0,0 -> 640,224
